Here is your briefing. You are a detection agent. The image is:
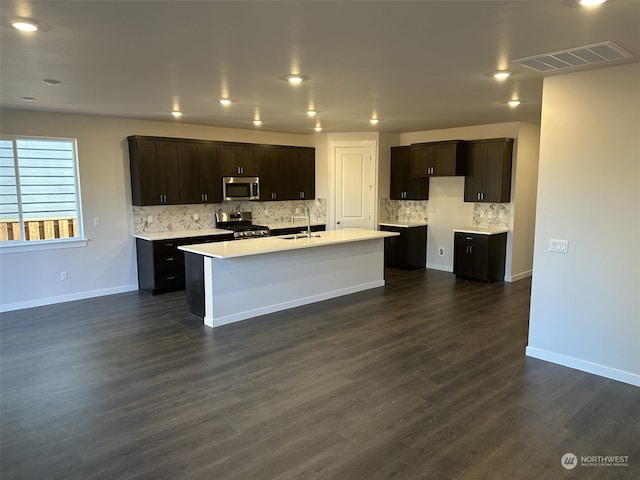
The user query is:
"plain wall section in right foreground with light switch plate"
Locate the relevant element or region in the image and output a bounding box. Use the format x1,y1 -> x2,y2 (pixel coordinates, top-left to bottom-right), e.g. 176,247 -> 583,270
527,63 -> 640,386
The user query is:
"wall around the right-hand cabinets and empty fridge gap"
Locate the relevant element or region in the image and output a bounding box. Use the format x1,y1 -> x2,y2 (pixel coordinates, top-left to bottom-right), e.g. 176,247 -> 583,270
400,123 -> 539,281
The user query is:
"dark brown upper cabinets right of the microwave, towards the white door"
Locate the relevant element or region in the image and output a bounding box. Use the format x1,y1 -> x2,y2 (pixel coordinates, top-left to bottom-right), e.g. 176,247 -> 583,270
258,146 -> 316,201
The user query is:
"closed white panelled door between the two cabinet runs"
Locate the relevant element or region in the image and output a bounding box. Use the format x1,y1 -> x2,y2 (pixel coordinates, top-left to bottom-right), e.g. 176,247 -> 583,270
334,145 -> 376,230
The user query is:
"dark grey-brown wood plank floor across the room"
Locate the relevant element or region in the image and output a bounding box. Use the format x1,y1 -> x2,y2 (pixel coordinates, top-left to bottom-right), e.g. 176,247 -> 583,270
0,270 -> 640,480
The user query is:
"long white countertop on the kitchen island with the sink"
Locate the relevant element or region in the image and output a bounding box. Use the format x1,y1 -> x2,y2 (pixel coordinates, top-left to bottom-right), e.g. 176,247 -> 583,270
178,228 -> 398,258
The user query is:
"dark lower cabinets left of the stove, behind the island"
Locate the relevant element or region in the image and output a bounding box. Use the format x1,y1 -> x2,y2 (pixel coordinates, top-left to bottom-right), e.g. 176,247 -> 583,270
136,234 -> 233,295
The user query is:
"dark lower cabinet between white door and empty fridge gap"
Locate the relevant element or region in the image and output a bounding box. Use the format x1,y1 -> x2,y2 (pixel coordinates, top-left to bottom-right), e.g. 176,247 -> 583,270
380,225 -> 427,270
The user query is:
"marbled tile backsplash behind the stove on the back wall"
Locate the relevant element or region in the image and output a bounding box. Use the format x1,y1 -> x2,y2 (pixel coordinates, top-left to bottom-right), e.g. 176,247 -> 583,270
133,198 -> 327,234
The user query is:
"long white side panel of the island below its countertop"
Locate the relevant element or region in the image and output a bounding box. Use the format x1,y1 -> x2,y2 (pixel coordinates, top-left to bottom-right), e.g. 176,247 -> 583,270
204,238 -> 384,327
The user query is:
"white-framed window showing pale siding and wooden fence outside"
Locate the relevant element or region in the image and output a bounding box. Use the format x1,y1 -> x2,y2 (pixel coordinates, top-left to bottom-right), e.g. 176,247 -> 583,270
0,137 -> 83,246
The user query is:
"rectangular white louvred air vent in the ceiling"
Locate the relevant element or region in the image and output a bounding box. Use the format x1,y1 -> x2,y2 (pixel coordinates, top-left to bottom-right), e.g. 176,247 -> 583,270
513,42 -> 633,72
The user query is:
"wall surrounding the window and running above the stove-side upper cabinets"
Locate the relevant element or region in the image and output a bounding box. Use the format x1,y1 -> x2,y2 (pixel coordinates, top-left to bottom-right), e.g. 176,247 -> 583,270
0,110 -> 314,311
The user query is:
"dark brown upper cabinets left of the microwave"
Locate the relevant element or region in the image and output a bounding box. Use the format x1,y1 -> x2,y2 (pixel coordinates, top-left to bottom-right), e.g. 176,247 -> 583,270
128,136 -> 222,205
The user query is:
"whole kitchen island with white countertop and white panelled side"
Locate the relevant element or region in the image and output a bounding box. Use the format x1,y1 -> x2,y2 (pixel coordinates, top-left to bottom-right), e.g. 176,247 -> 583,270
179,228 -> 397,327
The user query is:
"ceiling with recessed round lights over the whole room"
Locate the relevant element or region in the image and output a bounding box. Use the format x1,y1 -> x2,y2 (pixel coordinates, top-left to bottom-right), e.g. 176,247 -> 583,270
0,0 -> 640,133
